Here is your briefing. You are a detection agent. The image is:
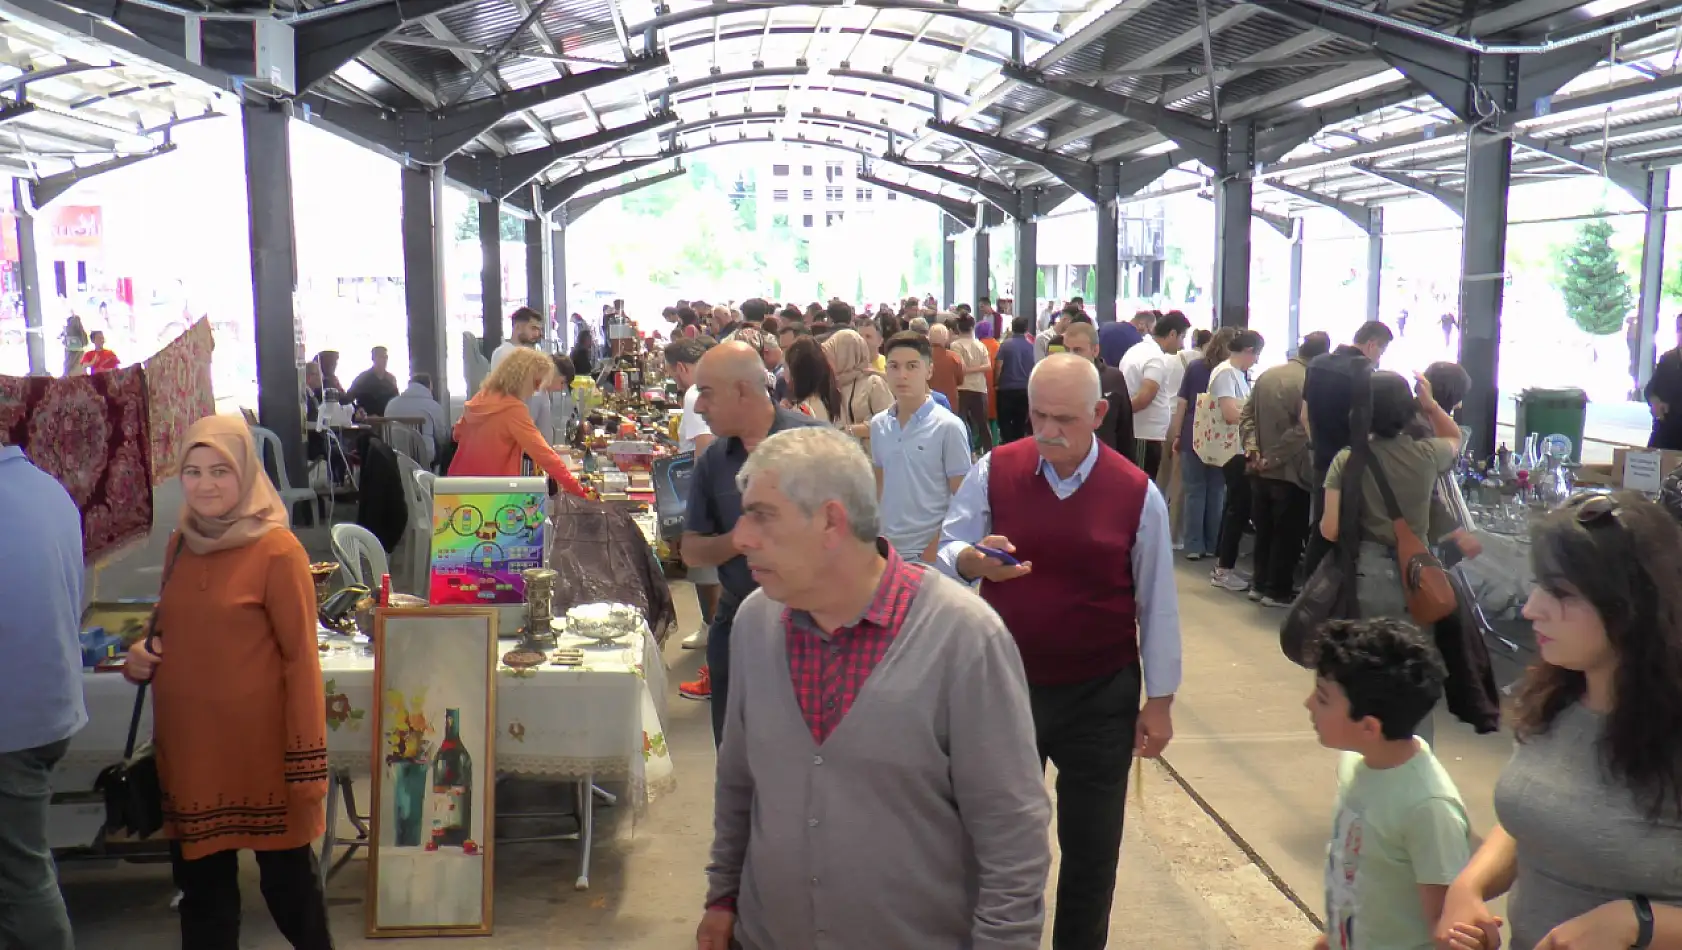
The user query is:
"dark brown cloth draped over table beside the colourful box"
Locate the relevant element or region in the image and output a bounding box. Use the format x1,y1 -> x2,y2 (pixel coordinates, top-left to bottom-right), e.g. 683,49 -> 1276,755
543,493 -> 678,646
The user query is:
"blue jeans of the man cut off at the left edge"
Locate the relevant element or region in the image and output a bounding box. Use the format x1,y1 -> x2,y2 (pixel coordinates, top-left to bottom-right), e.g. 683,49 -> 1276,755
0,738 -> 76,950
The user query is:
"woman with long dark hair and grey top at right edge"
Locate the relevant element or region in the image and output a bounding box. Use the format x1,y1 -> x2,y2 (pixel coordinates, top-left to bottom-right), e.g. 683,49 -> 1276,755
1436,491 -> 1682,950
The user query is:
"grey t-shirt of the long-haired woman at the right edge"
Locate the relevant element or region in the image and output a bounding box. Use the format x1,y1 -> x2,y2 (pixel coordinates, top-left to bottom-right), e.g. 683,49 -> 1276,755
1495,703 -> 1682,950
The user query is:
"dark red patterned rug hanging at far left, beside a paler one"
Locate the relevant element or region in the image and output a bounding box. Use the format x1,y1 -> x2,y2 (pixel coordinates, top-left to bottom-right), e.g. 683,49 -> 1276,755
0,367 -> 151,563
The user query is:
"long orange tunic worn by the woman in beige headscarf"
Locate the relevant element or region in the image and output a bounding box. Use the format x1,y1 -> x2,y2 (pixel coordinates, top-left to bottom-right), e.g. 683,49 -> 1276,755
151,531 -> 328,861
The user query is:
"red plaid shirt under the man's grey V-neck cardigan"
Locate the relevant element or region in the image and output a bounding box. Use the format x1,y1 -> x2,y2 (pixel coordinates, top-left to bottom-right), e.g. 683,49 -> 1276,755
782,545 -> 923,743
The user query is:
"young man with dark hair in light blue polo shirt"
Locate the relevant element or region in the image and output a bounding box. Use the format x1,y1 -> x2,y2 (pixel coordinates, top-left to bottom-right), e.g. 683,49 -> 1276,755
870,330 -> 971,563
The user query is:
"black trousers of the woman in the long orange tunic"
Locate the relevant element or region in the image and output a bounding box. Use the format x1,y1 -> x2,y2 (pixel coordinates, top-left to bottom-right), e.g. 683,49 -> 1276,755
170,846 -> 333,950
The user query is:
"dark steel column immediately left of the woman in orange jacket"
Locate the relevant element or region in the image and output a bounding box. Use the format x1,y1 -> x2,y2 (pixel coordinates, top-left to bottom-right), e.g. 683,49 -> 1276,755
400,168 -> 449,410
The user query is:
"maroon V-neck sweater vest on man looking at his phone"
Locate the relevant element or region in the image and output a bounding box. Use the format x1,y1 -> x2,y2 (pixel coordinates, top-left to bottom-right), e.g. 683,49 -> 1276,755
981,439 -> 1150,686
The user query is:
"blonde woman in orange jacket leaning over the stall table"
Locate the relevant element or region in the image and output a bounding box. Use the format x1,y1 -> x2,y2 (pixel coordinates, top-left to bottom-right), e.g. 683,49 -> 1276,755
449,348 -> 589,498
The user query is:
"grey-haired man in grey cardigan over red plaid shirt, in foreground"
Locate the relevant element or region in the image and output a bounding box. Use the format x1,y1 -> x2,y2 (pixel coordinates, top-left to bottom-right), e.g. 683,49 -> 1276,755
696,427 -> 1051,950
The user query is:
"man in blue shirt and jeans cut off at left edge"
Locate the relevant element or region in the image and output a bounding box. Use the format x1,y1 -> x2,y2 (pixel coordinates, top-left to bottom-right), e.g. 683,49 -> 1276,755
0,446 -> 87,950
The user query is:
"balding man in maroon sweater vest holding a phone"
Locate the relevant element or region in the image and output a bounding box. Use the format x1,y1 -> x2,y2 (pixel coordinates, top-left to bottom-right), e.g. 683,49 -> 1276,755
940,353 -> 1181,950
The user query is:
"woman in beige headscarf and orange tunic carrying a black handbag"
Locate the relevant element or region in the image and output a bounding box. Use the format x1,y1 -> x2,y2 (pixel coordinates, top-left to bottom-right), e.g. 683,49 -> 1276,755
126,415 -> 333,950
